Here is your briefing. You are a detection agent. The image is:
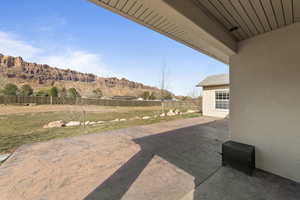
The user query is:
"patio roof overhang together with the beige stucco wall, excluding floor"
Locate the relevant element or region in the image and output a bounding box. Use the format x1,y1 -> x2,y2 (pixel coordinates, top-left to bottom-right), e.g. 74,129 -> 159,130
90,0 -> 300,182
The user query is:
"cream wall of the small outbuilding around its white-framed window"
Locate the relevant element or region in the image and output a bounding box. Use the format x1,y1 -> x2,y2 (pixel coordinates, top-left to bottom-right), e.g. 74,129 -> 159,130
202,85 -> 229,118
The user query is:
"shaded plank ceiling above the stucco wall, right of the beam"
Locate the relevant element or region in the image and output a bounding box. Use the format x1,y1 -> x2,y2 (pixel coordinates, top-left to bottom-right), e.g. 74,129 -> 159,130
194,0 -> 300,41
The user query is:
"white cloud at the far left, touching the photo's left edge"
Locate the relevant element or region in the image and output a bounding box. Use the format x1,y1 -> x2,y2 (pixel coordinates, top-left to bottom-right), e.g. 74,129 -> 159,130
0,31 -> 42,59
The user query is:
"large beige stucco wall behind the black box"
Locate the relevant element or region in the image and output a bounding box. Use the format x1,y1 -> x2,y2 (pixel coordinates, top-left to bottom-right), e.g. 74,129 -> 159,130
230,23 -> 300,182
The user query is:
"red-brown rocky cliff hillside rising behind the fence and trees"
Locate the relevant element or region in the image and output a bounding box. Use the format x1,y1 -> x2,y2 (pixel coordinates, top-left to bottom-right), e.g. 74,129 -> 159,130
0,54 -> 159,96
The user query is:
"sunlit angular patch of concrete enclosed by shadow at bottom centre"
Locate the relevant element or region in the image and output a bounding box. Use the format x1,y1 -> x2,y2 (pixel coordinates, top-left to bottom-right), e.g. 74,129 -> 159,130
115,156 -> 195,200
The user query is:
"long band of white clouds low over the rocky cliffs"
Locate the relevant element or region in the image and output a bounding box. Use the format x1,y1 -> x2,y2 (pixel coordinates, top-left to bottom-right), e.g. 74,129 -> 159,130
0,30 -> 120,77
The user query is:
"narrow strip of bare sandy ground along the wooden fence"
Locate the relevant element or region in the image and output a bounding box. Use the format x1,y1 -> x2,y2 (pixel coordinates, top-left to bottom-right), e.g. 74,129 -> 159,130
0,105 -> 160,115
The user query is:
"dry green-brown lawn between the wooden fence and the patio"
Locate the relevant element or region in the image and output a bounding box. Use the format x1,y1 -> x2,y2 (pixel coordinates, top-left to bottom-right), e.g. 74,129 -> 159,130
0,105 -> 200,153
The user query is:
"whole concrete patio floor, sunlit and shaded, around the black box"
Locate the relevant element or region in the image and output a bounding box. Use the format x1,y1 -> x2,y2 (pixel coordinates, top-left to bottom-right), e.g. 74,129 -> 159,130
0,117 -> 300,200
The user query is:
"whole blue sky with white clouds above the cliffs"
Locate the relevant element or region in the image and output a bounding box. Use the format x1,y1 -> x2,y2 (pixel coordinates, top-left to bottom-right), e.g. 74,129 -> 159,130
0,0 -> 228,95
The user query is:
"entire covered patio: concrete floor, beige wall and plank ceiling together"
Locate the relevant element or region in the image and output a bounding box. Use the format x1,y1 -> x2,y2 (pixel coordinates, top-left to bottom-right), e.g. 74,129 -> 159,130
0,0 -> 300,200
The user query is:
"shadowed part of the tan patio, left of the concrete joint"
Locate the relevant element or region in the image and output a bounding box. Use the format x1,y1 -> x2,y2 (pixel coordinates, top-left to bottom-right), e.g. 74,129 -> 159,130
85,119 -> 228,200
